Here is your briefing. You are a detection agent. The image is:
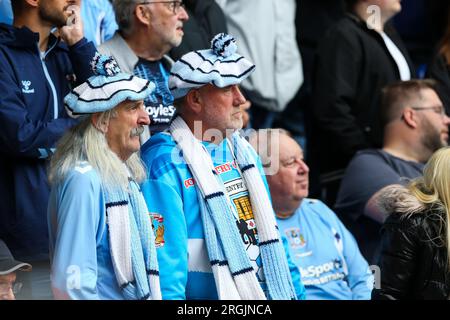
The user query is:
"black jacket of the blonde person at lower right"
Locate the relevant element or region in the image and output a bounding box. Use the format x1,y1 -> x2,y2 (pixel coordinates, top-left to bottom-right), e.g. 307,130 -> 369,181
372,187 -> 450,300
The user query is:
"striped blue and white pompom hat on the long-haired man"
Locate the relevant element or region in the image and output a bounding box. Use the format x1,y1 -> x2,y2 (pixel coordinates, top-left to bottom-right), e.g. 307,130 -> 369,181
64,53 -> 155,118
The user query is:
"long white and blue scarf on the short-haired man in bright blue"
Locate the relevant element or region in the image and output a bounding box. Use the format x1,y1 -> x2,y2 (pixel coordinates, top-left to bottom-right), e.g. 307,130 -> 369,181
170,117 -> 296,300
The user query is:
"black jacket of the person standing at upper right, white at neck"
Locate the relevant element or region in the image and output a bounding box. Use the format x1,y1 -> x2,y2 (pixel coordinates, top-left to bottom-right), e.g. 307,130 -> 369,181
312,14 -> 414,173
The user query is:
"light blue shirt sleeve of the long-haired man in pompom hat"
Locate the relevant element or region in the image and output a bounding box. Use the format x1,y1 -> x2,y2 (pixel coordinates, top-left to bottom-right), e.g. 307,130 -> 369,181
50,171 -> 104,300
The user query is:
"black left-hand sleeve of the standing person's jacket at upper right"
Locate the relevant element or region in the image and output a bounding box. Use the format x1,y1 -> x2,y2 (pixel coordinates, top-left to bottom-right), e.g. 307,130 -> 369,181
313,27 -> 368,157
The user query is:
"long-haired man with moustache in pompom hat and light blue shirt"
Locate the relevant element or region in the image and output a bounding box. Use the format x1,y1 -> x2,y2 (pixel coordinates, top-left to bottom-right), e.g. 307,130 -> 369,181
48,55 -> 161,300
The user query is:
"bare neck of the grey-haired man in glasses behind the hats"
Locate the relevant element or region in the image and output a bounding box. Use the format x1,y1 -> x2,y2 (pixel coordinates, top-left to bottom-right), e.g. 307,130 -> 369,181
122,30 -> 170,61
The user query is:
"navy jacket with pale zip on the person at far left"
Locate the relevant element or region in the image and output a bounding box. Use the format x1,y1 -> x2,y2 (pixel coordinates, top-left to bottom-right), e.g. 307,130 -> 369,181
0,24 -> 96,261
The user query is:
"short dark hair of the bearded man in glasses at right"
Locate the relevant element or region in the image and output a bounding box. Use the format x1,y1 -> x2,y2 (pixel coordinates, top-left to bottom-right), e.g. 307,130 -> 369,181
381,79 -> 436,127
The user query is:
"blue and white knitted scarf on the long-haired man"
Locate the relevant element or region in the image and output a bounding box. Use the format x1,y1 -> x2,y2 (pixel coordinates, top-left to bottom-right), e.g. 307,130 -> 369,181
104,178 -> 161,300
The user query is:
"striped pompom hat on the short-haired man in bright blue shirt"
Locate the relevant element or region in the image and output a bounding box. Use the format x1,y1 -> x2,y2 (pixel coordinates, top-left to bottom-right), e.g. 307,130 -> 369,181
169,33 -> 255,99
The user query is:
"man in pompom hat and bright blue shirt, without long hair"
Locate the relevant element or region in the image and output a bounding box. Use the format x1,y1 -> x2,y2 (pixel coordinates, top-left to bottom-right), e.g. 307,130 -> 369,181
141,34 -> 304,299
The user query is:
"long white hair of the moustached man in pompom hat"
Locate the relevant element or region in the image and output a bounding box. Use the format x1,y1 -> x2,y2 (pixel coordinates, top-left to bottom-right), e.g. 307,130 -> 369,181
48,109 -> 146,189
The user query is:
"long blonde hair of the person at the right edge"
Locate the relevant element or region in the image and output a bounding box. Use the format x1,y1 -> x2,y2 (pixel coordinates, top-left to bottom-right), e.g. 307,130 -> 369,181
408,147 -> 450,267
